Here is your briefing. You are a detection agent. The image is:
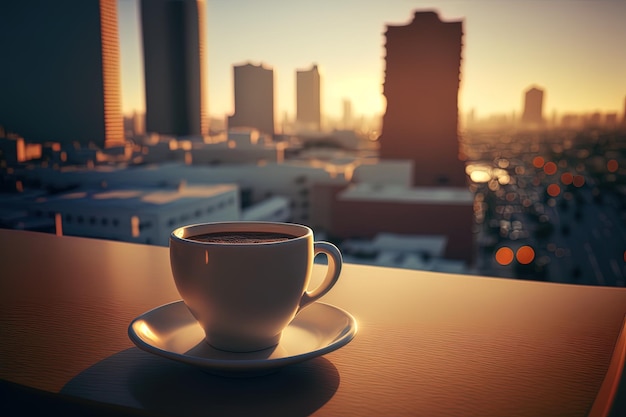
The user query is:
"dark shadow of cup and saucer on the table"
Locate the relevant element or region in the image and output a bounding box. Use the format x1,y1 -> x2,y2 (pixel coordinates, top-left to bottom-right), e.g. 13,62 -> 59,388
61,348 -> 340,416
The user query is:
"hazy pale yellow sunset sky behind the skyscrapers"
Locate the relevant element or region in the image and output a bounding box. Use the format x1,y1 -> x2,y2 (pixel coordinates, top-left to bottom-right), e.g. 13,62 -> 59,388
118,0 -> 626,118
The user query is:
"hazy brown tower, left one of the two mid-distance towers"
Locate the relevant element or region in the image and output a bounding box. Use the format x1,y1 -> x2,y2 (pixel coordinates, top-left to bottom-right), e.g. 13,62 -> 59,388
228,63 -> 274,135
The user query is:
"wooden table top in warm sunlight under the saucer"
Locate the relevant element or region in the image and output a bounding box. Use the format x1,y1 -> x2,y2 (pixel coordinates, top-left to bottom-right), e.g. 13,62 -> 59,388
0,230 -> 626,417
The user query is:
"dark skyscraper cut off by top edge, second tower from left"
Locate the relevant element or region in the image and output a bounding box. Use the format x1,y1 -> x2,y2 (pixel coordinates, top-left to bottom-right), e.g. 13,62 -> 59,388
141,0 -> 209,136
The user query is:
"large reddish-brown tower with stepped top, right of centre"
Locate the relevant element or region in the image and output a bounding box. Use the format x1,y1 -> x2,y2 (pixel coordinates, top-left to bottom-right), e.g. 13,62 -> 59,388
379,12 -> 467,187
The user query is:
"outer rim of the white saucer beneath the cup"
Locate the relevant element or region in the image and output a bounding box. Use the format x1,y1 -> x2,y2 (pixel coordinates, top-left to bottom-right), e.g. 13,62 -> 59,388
128,300 -> 358,372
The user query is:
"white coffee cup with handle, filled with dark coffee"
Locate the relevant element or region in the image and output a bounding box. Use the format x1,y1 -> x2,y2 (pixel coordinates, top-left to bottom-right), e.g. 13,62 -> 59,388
170,221 -> 342,352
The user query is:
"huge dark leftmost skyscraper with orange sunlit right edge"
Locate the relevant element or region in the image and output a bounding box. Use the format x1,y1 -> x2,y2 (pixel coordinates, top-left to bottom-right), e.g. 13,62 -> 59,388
0,0 -> 124,148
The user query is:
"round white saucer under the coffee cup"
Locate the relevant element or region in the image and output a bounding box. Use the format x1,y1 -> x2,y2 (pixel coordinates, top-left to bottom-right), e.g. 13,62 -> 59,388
128,301 -> 357,374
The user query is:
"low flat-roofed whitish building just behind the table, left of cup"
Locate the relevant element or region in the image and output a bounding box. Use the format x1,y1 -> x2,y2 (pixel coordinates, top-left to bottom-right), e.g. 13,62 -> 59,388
29,184 -> 241,246
